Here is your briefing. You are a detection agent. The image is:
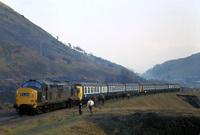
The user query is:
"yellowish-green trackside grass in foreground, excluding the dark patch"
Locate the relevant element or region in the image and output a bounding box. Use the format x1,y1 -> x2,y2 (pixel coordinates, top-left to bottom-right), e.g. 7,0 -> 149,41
0,91 -> 200,135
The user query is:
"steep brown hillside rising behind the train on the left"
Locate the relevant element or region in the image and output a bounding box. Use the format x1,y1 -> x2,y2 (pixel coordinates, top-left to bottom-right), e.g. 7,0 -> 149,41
0,2 -> 143,101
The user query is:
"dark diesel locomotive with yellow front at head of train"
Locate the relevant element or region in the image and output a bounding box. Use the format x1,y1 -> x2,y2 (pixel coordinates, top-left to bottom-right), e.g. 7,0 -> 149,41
15,80 -> 78,114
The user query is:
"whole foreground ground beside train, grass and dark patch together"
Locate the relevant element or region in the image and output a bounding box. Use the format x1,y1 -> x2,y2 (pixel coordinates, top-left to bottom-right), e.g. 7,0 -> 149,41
0,91 -> 200,135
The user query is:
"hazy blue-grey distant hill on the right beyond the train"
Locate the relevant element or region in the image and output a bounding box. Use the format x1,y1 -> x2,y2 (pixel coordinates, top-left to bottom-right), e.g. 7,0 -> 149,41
142,53 -> 200,88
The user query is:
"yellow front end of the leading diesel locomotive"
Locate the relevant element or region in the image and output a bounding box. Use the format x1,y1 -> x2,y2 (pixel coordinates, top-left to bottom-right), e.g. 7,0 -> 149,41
16,87 -> 37,114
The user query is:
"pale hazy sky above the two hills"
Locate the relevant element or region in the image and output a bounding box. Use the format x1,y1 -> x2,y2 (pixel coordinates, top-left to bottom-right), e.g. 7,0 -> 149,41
1,0 -> 200,73
